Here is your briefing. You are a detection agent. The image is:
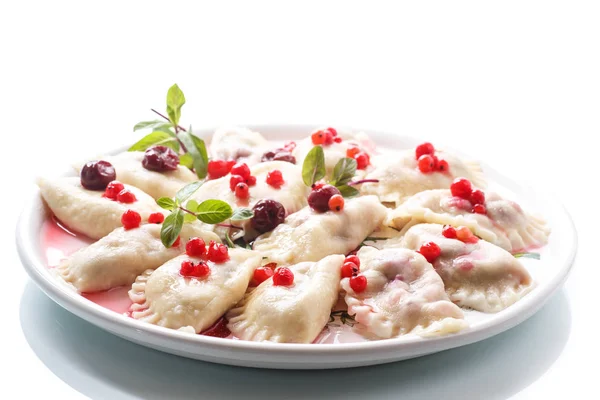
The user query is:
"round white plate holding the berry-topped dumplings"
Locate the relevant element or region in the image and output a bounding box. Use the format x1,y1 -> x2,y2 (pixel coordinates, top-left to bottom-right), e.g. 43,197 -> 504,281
16,125 -> 577,369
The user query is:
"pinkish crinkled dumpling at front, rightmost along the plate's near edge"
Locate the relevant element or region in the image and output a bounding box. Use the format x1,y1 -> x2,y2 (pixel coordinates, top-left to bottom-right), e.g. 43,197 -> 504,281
342,246 -> 466,339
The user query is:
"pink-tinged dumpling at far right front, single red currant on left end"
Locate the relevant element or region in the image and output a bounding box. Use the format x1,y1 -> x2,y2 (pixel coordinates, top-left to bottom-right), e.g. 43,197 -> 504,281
402,224 -> 533,312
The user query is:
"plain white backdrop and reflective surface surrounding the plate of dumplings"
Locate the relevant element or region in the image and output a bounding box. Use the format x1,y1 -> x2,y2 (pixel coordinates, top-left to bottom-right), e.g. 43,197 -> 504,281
0,1 -> 600,399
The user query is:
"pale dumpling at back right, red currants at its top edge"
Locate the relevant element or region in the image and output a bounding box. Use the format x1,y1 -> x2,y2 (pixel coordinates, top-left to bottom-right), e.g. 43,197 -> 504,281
360,150 -> 486,205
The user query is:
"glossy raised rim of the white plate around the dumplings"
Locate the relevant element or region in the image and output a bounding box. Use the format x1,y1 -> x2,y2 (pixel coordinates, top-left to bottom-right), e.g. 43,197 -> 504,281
15,124 -> 578,368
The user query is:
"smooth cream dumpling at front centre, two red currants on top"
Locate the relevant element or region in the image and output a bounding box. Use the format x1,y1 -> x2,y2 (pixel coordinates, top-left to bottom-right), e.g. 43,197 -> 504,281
227,255 -> 344,343
